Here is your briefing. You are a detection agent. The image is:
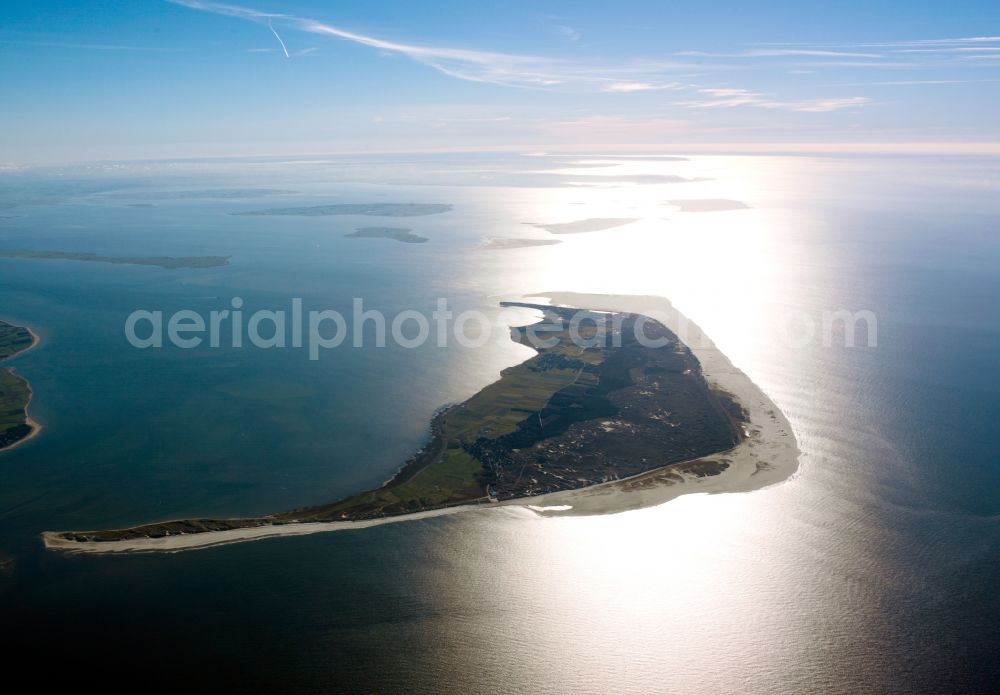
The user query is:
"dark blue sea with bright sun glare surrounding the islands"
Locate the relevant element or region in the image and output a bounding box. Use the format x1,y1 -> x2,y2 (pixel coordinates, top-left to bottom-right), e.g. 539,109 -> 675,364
0,156 -> 1000,695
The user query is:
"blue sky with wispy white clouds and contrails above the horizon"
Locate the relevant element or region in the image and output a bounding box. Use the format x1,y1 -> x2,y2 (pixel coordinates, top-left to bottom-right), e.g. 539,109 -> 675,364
0,0 -> 1000,167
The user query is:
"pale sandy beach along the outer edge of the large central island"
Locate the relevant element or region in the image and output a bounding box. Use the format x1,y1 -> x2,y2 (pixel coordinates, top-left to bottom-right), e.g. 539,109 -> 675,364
42,292 -> 799,554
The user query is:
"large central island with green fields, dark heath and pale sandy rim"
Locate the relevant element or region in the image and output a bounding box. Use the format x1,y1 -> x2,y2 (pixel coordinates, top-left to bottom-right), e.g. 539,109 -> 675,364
43,294 -> 798,553
